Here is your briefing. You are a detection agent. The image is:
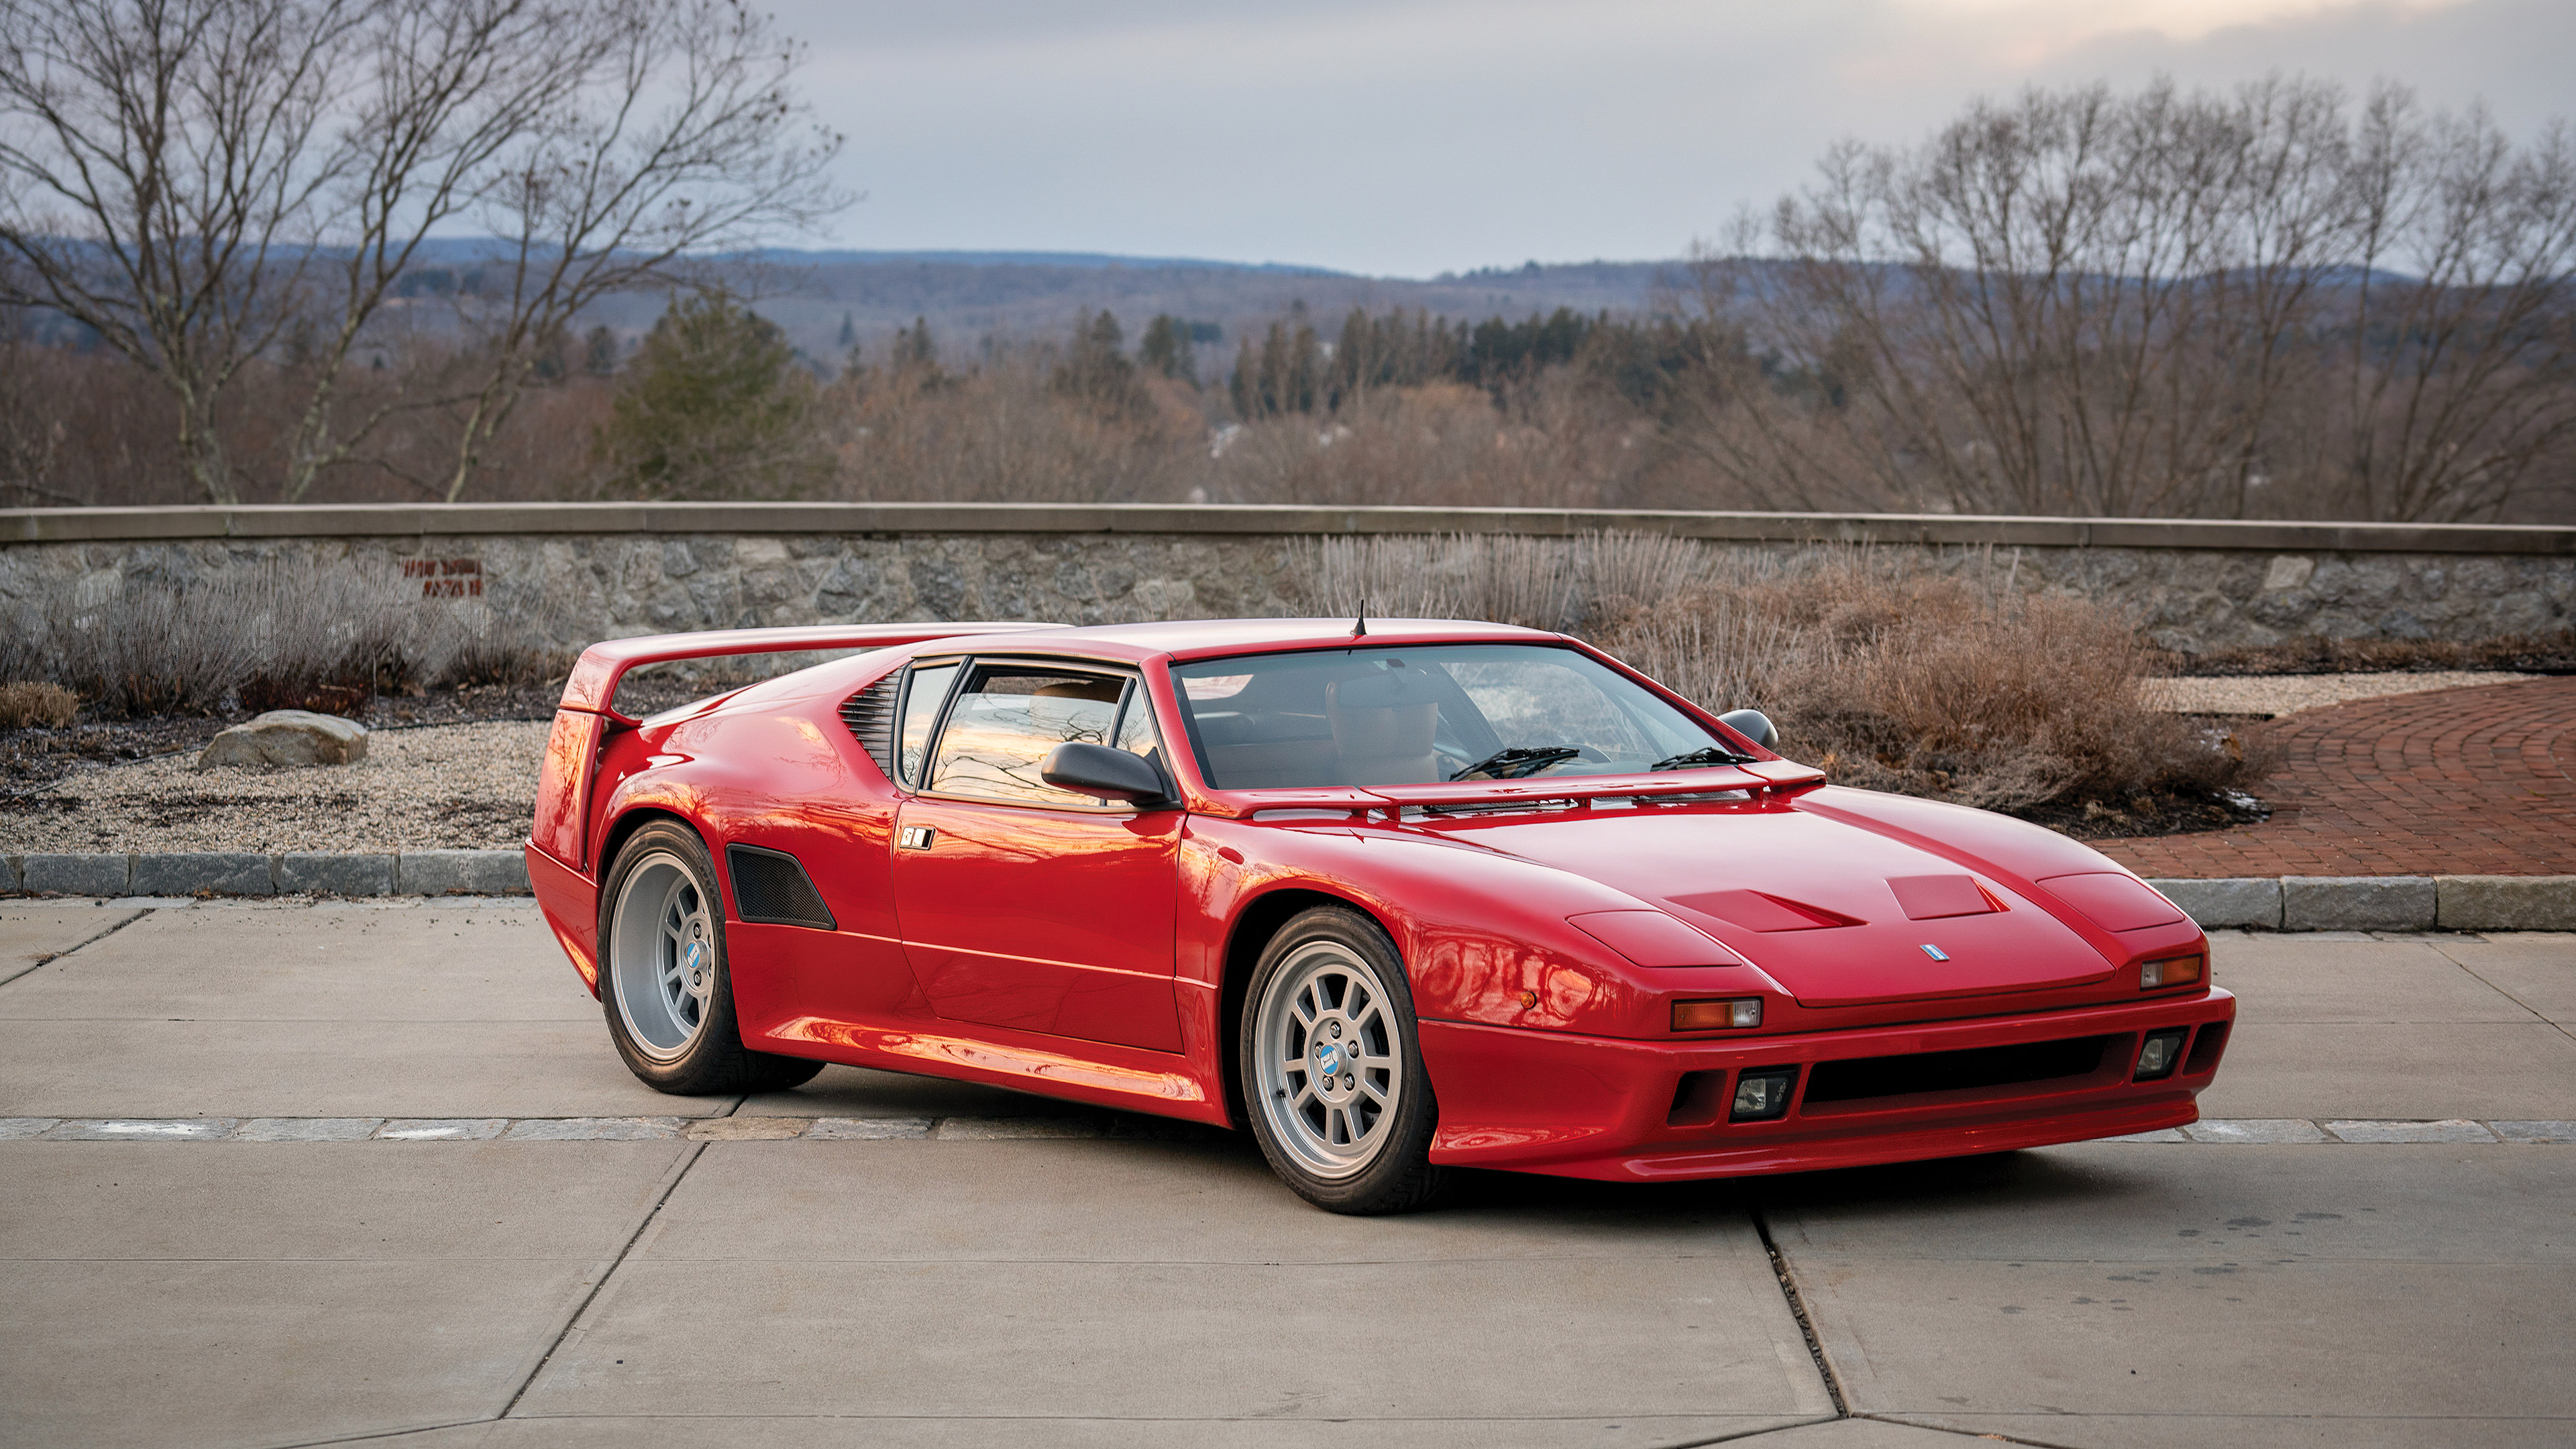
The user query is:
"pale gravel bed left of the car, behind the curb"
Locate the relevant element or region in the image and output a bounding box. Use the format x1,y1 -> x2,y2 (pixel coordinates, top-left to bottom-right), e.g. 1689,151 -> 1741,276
0,719 -> 549,856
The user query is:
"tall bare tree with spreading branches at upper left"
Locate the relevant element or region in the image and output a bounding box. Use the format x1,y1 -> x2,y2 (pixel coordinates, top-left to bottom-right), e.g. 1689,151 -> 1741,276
0,0 -> 843,500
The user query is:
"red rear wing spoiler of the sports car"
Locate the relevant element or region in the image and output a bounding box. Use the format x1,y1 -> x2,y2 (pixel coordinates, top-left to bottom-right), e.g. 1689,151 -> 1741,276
528,610 -> 1061,871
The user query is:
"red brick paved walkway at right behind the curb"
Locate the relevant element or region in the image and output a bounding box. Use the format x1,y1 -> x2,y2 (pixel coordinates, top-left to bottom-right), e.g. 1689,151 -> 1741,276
2097,678 -> 2576,879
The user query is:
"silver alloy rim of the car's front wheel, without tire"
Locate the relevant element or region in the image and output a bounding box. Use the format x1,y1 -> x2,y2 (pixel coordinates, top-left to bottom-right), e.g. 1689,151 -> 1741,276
1252,941 -> 1404,1178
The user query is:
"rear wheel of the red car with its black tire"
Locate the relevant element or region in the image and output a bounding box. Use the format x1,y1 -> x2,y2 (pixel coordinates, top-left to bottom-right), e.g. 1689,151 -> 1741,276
600,820 -> 824,1095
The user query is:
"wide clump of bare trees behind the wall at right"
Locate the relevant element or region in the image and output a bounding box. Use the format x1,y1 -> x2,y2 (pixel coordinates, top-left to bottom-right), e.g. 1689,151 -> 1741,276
1690,77 -> 2576,519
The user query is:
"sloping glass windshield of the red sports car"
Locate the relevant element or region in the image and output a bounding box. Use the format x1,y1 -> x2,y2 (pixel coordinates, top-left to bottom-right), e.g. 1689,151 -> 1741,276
1172,645 -> 1739,789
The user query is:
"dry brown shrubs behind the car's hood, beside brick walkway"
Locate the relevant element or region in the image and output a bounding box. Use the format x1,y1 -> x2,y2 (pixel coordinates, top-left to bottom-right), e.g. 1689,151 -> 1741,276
1301,534 -> 2269,810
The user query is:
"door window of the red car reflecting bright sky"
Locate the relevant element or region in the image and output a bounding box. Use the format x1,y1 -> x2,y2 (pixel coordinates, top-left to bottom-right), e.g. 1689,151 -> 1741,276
927,663 -> 1126,804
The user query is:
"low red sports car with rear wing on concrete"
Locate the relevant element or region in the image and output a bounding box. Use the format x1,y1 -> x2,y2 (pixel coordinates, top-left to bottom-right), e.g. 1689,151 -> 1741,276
528,619 -> 2236,1212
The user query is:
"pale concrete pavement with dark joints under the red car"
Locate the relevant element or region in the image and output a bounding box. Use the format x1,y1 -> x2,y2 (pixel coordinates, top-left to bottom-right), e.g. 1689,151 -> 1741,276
0,902 -> 2576,1449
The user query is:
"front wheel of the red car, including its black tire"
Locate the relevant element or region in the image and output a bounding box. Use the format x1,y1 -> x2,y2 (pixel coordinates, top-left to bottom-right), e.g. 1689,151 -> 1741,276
1234,905 -> 1442,1214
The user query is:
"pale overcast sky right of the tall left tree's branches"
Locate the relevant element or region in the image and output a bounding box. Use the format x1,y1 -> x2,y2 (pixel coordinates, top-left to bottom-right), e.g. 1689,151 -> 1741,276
778,0 -> 2576,276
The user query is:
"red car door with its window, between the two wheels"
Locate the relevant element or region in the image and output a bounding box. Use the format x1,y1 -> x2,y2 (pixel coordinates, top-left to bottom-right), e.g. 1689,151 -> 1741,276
894,660 -> 1183,1052
